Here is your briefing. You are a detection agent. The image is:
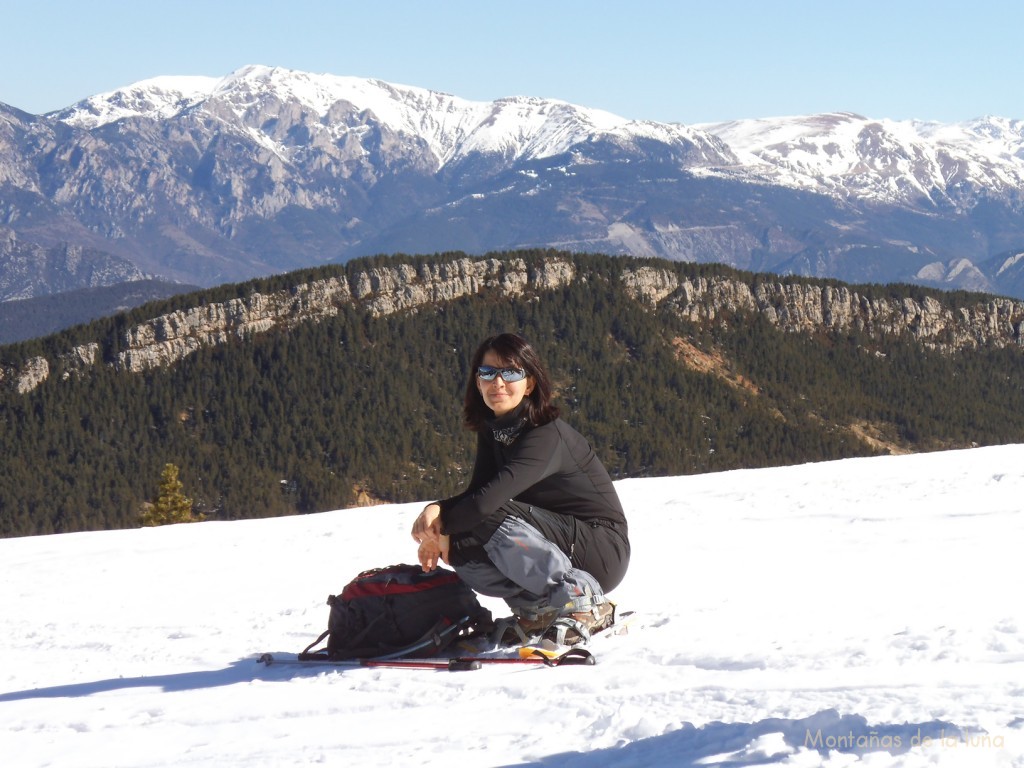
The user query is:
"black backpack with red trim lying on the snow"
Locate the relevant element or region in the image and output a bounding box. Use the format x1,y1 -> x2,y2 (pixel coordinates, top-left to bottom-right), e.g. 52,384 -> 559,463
299,565 -> 492,659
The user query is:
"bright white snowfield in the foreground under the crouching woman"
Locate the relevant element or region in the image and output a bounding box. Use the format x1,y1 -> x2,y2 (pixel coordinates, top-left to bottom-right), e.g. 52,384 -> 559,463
0,445 -> 1024,768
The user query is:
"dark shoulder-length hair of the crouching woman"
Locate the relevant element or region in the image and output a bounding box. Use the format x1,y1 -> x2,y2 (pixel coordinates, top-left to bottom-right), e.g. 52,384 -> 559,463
462,334 -> 558,432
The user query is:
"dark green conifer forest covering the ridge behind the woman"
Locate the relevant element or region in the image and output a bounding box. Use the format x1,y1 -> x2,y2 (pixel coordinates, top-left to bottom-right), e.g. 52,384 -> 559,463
0,252 -> 1024,536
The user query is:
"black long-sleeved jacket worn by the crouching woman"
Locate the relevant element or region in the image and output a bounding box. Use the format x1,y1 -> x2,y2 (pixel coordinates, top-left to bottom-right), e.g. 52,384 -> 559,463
438,408 -> 627,542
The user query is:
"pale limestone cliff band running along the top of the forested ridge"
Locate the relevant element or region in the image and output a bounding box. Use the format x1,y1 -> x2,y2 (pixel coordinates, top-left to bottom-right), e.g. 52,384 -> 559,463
0,257 -> 1024,392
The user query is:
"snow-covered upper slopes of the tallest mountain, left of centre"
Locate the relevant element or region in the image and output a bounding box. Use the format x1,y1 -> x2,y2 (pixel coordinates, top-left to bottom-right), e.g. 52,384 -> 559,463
55,67 -> 737,170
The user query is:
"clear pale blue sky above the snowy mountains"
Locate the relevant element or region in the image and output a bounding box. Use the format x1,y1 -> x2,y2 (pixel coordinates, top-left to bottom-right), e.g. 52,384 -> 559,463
0,0 -> 1024,123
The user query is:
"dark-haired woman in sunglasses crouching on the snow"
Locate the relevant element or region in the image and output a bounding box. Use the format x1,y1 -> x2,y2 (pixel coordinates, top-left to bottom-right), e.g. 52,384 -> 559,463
413,334 -> 630,644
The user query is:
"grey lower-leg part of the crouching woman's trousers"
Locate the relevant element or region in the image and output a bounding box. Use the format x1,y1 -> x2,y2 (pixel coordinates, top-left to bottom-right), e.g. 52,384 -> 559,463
452,515 -> 607,615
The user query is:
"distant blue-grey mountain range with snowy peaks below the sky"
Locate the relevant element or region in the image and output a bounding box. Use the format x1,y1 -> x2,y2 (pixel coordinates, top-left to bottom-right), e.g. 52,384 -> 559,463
0,60 -> 1024,313
